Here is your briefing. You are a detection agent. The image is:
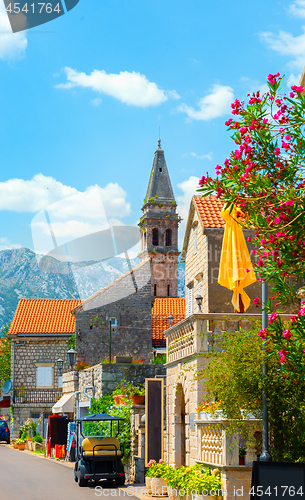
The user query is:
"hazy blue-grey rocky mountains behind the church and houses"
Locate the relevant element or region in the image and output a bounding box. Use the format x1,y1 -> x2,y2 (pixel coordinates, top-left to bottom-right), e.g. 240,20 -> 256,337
0,248 -> 184,329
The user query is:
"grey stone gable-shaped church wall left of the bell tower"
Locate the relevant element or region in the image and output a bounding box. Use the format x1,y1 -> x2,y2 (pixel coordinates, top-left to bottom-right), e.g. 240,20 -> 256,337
75,260 -> 152,365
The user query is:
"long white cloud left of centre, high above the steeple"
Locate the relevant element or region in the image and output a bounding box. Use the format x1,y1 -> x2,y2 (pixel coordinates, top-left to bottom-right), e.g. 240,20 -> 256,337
56,68 -> 179,108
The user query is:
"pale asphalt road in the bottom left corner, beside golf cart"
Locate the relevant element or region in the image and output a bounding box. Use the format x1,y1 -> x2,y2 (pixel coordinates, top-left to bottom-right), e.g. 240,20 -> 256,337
0,444 -> 135,500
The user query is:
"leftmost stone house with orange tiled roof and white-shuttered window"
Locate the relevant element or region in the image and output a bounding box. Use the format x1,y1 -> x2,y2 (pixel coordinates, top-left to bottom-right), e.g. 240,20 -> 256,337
8,299 -> 81,436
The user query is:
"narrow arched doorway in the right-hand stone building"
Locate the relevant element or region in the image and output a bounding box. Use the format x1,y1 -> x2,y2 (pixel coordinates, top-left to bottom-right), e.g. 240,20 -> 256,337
174,384 -> 186,467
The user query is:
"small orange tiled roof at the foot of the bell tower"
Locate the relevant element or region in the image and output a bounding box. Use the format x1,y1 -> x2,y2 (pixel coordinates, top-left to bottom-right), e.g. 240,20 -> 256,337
151,297 -> 185,348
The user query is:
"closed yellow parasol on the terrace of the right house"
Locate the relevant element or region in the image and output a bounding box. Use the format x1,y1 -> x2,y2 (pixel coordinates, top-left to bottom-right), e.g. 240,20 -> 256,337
218,207 -> 256,313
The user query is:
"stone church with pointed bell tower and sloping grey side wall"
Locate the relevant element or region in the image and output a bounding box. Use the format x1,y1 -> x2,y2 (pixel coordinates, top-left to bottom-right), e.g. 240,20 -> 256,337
73,140 -> 185,365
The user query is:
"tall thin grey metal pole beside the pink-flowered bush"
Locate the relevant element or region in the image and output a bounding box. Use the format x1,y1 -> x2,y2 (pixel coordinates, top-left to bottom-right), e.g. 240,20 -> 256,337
259,281 -> 272,462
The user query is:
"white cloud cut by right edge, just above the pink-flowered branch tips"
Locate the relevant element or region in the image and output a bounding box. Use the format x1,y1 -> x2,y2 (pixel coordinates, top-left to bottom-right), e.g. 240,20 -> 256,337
260,26 -> 305,70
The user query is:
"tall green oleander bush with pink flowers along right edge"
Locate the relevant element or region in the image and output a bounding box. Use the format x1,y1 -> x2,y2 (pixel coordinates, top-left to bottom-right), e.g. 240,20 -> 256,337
199,73 -> 305,376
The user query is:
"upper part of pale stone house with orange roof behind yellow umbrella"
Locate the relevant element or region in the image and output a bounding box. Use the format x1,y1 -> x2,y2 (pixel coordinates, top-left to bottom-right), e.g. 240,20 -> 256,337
181,195 -> 261,316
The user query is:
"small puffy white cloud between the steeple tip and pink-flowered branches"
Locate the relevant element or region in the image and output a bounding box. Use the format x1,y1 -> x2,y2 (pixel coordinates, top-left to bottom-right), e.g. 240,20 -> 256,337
178,84 -> 234,120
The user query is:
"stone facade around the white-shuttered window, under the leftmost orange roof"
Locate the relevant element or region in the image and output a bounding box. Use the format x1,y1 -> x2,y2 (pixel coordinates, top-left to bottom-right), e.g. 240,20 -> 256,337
11,336 -> 69,389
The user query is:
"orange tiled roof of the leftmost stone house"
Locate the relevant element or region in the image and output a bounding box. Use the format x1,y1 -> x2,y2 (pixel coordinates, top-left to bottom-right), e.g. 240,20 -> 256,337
8,299 -> 81,335
